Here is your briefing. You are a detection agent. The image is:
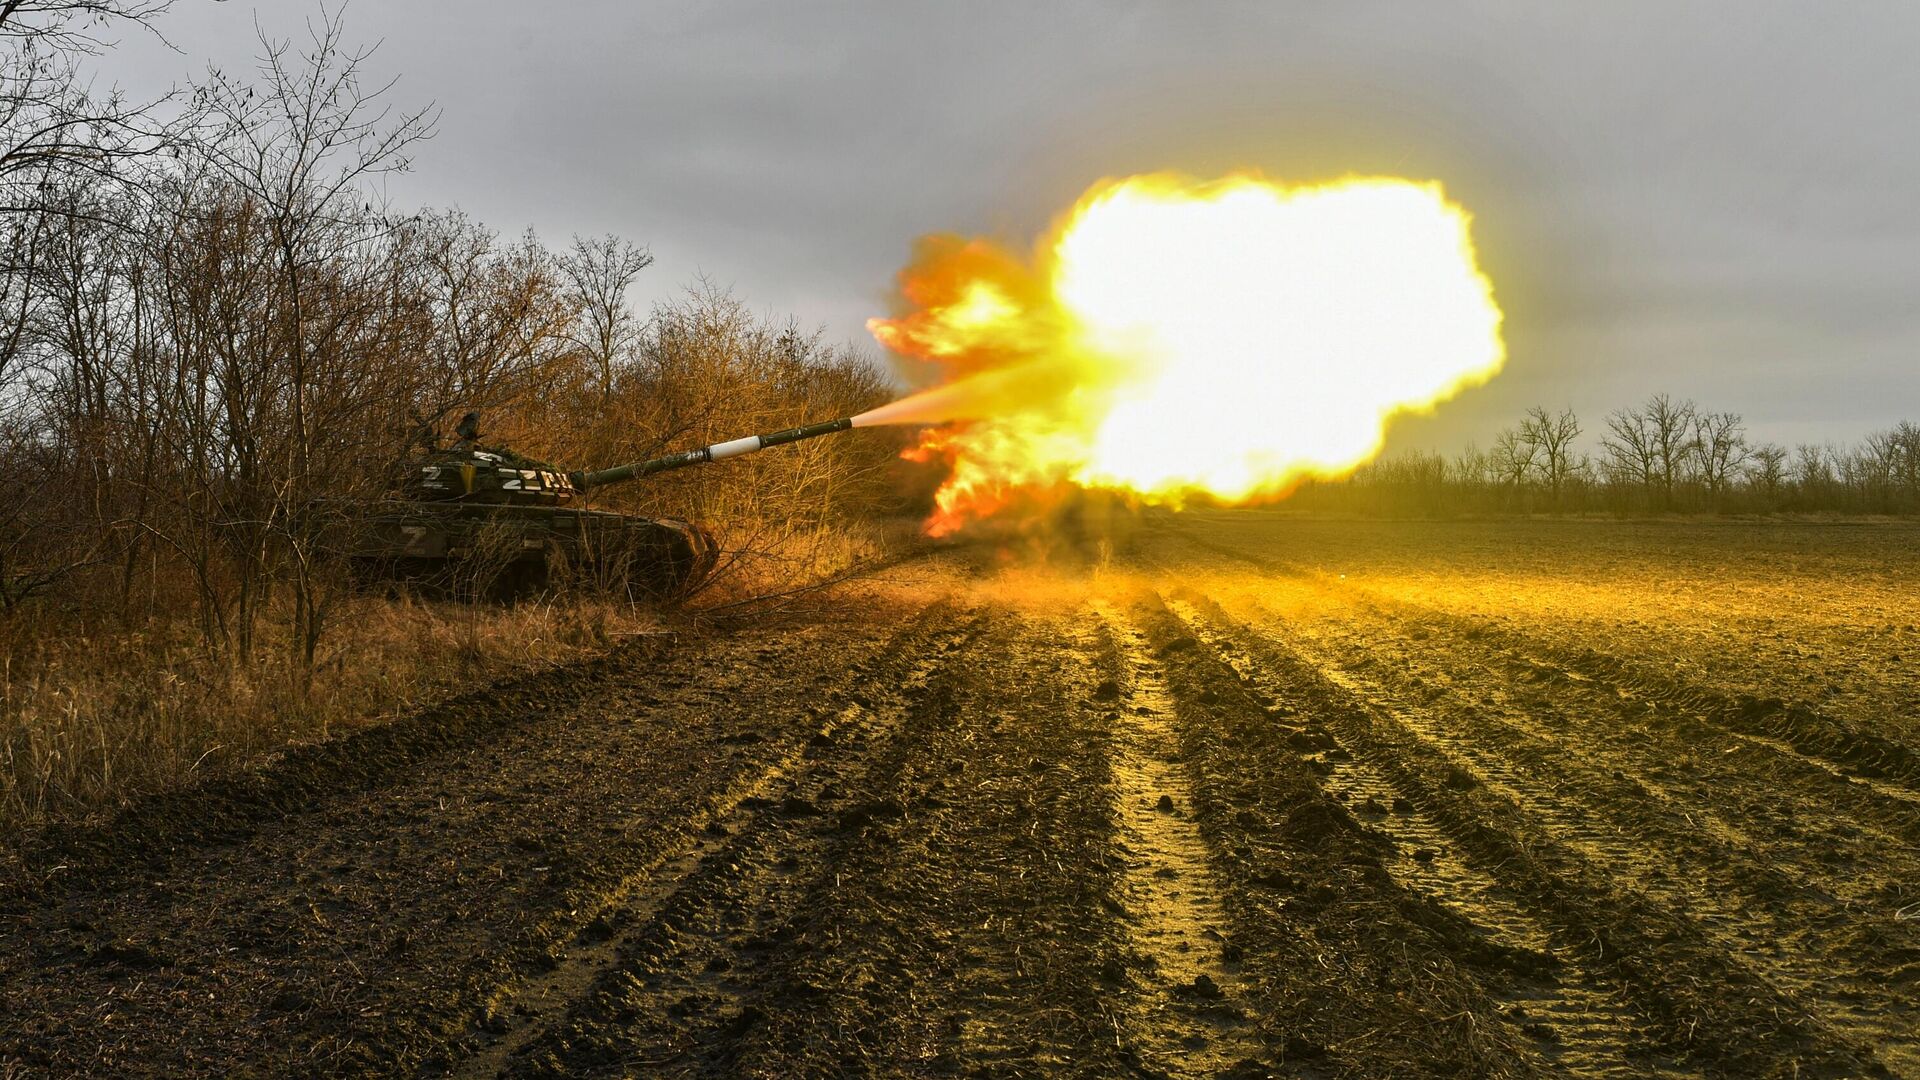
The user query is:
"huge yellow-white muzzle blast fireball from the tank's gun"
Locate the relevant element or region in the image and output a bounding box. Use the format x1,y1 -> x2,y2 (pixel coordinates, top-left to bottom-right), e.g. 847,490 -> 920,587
872,173 -> 1505,530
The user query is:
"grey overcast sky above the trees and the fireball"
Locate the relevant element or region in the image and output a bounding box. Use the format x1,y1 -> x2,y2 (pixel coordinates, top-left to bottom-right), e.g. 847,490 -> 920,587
102,0 -> 1920,448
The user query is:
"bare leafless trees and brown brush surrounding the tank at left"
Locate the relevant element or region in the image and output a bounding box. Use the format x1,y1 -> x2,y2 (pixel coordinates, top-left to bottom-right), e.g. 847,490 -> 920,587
0,0 -> 895,665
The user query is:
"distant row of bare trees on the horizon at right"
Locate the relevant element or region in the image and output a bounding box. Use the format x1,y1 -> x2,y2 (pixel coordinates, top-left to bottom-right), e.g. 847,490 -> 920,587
1288,394 -> 1920,517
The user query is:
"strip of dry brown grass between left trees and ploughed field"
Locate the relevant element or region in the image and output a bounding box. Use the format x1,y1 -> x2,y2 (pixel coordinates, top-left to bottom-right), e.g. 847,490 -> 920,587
0,519 -> 914,836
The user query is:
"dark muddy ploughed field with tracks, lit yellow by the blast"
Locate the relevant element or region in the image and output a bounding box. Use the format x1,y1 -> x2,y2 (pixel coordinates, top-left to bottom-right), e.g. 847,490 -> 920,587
0,511 -> 1920,1078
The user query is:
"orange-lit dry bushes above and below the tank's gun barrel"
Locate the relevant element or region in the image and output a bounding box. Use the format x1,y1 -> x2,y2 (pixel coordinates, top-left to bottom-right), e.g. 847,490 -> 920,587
493,286 -> 902,600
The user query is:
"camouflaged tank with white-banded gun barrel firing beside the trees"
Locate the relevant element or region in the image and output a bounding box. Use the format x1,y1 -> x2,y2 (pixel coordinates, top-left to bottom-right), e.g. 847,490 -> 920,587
351,413 -> 852,600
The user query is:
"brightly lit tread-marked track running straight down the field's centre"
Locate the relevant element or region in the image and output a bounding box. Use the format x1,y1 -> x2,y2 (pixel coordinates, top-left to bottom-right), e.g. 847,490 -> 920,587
1091,603 -> 1271,1078
